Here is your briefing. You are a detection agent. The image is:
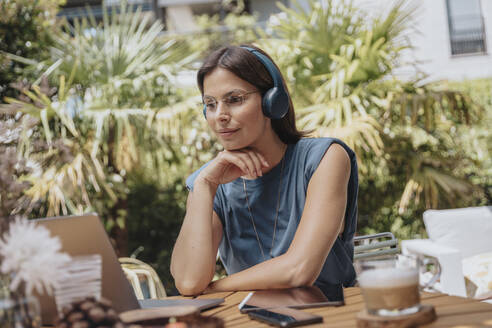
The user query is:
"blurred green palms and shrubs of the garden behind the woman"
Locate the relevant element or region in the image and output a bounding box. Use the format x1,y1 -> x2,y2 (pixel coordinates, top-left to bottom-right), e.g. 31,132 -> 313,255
0,0 -> 492,294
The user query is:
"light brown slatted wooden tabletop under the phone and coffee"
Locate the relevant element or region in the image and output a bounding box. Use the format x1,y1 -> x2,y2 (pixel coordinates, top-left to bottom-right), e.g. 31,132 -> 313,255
191,287 -> 492,328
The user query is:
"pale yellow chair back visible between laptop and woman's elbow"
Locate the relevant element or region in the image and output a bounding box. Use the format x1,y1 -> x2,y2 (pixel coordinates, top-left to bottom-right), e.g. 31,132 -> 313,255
118,257 -> 167,299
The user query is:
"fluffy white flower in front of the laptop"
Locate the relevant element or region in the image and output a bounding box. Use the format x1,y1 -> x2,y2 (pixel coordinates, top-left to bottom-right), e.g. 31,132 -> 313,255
0,219 -> 71,295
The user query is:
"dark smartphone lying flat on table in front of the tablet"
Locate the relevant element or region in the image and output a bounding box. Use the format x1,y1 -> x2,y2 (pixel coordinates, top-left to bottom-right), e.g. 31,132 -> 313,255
248,308 -> 323,327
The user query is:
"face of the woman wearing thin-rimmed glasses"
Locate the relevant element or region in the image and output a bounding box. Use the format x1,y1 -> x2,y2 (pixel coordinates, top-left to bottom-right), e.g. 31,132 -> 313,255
203,67 -> 271,150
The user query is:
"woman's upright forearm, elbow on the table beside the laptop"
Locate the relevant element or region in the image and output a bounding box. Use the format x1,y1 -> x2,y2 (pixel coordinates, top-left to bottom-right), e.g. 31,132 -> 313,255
171,179 -> 217,295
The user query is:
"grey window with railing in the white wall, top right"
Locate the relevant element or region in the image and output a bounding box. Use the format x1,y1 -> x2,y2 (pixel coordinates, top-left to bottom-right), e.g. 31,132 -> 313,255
446,0 -> 486,55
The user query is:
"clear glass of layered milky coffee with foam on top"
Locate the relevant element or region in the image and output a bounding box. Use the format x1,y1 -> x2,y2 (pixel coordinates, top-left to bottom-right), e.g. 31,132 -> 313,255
355,255 -> 432,316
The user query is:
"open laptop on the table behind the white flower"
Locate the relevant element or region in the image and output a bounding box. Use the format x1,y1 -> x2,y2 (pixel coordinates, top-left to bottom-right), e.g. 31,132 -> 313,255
33,213 -> 224,325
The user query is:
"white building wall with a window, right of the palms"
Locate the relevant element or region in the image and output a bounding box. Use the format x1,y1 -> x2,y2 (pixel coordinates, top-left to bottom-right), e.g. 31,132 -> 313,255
354,0 -> 492,81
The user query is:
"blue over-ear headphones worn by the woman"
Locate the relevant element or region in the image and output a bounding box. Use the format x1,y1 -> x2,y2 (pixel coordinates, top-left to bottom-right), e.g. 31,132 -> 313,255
203,46 -> 289,120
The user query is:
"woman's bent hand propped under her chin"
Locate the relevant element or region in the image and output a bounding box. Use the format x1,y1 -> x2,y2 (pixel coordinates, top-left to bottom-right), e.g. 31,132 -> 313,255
198,148 -> 269,187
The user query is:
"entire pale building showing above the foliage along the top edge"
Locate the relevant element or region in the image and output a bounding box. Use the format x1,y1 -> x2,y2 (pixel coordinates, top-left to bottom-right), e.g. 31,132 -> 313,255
60,0 -> 492,81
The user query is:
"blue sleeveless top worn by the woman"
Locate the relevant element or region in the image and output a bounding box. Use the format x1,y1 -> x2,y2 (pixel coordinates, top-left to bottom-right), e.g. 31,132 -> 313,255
186,138 -> 358,287
